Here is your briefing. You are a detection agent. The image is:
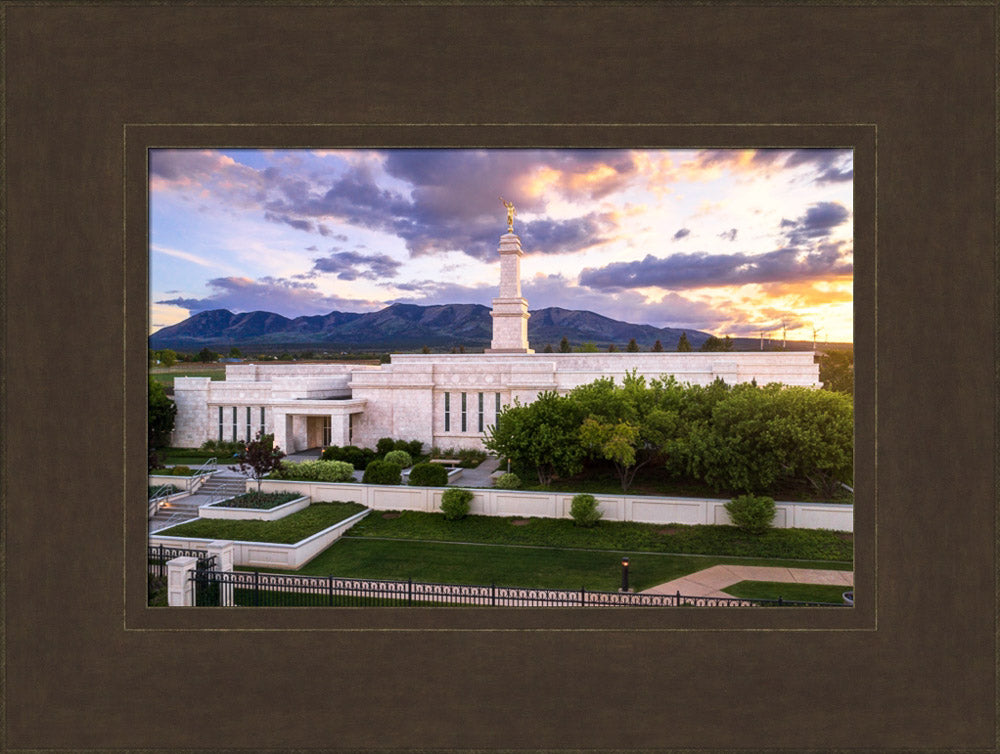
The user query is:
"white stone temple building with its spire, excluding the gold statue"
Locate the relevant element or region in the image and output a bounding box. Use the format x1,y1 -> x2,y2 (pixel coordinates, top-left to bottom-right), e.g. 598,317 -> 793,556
171,227 -> 820,453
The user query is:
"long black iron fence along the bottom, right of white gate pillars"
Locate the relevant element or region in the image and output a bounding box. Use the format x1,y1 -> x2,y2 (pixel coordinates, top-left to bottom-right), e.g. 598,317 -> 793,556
191,567 -> 845,607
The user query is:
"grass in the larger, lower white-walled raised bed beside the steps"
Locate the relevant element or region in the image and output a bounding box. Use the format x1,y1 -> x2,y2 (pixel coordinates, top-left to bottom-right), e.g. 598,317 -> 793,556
157,503 -> 365,544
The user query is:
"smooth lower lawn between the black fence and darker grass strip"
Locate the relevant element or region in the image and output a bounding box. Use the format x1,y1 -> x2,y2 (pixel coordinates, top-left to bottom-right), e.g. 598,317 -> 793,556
252,536 -> 852,599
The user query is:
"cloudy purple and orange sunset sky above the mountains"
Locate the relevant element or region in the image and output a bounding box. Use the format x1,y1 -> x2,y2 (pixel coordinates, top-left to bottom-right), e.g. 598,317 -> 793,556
149,149 -> 854,341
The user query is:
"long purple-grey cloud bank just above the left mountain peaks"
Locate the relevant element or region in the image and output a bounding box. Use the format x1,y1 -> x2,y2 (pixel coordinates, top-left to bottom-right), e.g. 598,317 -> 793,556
154,277 -> 384,317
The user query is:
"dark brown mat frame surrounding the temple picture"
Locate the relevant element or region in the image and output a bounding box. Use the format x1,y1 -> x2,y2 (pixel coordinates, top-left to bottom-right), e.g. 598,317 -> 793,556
3,3 -> 996,751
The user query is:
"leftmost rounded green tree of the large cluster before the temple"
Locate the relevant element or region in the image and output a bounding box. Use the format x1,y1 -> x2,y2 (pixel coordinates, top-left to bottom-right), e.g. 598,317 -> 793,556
483,392 -> 584,487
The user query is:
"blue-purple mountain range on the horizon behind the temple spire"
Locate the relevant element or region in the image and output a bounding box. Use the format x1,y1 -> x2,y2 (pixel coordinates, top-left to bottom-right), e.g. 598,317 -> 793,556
149,304 -> 728,351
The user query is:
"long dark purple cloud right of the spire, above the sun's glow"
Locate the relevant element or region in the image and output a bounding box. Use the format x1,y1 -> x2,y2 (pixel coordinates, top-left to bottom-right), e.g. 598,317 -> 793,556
580,244 -> 853,290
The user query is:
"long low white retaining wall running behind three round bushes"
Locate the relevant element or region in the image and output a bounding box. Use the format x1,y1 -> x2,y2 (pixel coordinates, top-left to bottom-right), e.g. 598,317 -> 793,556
261,479 -> 854,531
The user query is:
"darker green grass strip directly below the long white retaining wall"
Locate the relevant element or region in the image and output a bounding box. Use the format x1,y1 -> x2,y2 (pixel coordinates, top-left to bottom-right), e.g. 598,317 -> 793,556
349,511 -> 853,568
